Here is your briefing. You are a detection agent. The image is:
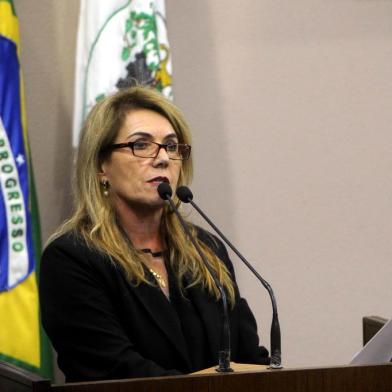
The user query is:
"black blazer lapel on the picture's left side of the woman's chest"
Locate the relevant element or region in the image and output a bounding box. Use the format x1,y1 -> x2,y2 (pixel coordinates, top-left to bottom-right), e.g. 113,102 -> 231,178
132,283 -> 191,369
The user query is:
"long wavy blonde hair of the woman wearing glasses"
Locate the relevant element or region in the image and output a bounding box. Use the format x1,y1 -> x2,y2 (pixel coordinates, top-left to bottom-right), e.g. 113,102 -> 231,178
49,87 -> 235,306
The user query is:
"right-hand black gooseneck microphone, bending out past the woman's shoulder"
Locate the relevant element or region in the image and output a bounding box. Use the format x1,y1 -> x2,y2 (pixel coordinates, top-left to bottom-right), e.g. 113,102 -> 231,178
176,186 -> 282,369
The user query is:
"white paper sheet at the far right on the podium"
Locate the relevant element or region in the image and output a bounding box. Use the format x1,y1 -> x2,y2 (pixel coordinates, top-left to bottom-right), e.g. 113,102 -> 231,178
350,319 -> 392,365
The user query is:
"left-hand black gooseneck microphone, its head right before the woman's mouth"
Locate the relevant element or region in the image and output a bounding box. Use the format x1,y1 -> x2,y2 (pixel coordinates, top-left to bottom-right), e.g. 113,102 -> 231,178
157,182 -> 233,373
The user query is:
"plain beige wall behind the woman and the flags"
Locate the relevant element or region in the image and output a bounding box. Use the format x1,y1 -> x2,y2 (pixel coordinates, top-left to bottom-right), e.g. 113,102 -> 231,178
15,0 -> 392,374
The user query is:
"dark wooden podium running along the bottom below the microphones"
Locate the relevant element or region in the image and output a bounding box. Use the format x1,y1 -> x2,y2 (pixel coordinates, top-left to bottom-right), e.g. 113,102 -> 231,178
0,363 -> 392,392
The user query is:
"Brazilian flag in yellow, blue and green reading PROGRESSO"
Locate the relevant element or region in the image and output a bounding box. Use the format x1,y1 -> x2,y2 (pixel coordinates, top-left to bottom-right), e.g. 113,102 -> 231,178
0,0 -> 52,378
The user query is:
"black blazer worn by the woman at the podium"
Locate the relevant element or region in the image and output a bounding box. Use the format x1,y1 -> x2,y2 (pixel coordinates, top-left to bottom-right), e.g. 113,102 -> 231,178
40,230 -> 269,382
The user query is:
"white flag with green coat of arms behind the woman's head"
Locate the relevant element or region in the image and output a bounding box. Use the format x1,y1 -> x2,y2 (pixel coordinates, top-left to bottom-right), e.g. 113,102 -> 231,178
73,0 -> 172,147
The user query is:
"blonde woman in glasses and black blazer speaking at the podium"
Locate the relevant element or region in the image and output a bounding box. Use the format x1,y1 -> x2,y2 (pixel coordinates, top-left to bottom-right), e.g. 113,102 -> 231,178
40,87 -> 268,382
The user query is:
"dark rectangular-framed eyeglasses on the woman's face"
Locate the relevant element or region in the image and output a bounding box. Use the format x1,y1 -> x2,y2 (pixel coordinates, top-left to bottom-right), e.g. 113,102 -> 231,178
103,142 -> 192,160
